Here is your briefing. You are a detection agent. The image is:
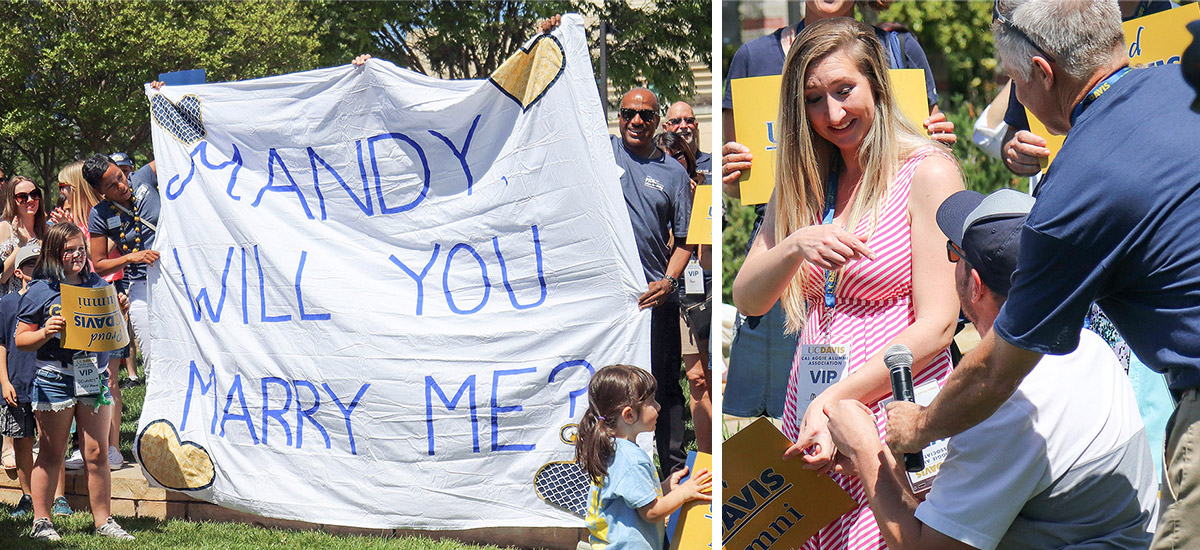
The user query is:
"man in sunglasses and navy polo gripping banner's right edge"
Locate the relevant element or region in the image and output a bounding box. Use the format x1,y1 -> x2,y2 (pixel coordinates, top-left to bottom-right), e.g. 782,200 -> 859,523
612,88 -> 692,479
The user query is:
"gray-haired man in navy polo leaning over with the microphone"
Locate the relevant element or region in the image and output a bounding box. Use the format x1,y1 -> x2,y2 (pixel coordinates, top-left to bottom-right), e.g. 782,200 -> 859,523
887,0 -> 1200,549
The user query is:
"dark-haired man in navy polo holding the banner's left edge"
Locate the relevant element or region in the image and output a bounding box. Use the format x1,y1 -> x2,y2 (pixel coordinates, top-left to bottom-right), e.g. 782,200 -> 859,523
83,155 -> 160,376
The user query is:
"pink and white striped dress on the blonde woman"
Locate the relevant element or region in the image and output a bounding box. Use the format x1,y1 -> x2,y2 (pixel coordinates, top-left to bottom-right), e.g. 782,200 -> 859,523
784,149 -> 950,550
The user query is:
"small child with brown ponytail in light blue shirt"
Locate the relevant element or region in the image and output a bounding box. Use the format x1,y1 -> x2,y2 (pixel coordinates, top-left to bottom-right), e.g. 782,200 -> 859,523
575,365 -> 713,550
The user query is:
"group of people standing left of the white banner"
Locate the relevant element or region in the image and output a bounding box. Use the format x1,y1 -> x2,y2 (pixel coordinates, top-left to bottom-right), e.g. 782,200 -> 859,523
0,153 -> 158,540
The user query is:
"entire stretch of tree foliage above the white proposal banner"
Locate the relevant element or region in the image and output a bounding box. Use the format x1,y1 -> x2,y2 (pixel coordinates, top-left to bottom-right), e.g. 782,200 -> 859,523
0,0 -> 712,187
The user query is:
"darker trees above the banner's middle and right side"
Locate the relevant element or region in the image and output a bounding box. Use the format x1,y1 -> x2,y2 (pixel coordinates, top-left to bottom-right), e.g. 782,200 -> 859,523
314,0 -> 712,104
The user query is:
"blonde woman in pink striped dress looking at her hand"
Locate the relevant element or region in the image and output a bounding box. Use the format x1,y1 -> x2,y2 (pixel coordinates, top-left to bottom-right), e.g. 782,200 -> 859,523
733,18 -> 962,549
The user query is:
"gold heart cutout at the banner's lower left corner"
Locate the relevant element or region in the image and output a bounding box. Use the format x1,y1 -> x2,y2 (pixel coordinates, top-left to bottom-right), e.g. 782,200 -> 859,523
136,420 -> 216,491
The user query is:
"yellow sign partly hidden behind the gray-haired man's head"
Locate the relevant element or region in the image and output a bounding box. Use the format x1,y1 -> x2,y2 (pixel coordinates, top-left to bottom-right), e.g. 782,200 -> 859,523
1026,4 -> 1200,172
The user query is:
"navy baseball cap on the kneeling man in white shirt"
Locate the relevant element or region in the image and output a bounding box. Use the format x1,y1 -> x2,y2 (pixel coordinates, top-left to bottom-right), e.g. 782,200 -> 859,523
937,189 -> 1033,295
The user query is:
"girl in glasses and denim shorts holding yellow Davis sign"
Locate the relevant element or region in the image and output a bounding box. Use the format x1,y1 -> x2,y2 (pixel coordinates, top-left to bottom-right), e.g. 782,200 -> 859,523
16,222 -> 133,540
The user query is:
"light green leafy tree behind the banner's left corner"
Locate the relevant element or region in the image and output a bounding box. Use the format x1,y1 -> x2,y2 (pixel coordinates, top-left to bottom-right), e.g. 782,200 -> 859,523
0,1 -> 318,181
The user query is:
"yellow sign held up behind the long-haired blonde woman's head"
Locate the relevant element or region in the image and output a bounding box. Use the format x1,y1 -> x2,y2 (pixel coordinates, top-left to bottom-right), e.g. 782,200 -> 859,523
730,68 -> 929,204
